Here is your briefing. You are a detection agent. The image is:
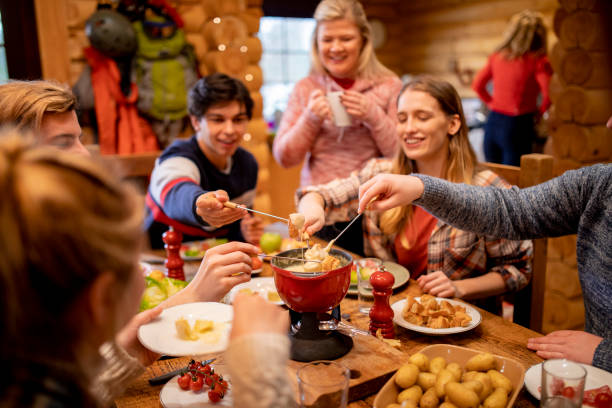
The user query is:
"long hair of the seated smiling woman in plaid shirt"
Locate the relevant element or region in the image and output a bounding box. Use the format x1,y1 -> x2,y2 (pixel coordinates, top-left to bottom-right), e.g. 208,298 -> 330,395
380,75 -> 478,239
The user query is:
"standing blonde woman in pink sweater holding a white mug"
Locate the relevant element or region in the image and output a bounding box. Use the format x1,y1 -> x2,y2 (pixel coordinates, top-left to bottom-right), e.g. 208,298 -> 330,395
273,0 -> 401,252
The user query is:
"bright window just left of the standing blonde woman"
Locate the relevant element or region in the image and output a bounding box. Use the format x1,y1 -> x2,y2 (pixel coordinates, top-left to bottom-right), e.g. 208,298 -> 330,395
259,17 -> 315,125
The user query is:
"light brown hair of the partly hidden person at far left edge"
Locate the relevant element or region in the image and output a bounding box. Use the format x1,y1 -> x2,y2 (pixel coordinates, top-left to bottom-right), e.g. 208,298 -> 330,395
0,81 -> 77,134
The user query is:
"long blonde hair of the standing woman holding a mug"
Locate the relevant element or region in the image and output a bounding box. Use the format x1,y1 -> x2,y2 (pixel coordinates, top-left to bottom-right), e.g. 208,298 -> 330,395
310,0 -> 397,79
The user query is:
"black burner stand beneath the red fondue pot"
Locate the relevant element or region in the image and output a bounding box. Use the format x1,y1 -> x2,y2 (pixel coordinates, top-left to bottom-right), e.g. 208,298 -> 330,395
289,306 -> 353,362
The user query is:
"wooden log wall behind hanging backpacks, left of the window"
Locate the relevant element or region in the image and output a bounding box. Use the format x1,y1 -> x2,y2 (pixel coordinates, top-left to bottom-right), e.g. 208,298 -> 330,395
35,0 -> 271,217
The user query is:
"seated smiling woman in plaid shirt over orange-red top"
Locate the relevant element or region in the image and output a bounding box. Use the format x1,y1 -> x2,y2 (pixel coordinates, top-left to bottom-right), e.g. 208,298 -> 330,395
298,77 -> 532,313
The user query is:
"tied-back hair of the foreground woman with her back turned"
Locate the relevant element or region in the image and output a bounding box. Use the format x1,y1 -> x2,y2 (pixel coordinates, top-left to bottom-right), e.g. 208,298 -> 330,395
0,129 -> 143,402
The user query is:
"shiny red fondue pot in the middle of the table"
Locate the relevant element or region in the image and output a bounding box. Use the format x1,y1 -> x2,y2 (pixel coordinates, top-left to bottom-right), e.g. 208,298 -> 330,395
270,249 -> 353,313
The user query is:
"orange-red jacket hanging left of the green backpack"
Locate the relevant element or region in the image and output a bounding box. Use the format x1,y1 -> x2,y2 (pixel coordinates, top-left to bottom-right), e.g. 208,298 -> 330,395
85,47 -> 159,154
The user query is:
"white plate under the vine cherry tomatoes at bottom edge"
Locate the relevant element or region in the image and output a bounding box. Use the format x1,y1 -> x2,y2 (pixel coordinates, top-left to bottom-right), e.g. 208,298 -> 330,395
159,366 -> 232,408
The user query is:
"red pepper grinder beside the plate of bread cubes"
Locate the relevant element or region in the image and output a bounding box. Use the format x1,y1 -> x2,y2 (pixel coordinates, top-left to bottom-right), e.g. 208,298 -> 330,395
370,266 -> 395,339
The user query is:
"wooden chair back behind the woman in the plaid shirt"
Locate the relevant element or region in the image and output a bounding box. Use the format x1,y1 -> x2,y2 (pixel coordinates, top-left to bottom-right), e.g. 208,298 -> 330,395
482,153 -> 553,332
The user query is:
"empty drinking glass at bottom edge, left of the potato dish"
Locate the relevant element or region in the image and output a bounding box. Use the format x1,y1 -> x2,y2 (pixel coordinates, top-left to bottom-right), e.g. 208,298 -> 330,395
297,360 -> 350,408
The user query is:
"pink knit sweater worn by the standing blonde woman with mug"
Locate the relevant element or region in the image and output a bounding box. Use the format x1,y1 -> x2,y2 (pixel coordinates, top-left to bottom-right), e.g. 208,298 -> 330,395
273,74 -> 402,187
